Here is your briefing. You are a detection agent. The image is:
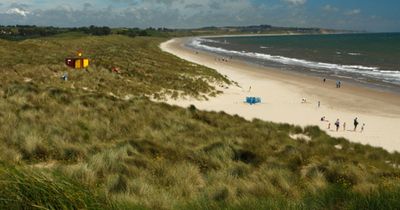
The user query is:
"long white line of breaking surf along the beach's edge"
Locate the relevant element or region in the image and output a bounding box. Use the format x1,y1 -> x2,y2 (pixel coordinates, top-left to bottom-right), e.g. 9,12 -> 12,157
190,38 -> 400,84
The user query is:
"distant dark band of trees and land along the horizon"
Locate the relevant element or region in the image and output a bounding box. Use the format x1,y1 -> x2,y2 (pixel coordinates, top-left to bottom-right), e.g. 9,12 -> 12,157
0,25 -> 344,40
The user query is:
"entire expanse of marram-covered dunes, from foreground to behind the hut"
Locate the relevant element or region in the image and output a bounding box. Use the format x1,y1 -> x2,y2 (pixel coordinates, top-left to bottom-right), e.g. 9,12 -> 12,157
0,35 -> 400,209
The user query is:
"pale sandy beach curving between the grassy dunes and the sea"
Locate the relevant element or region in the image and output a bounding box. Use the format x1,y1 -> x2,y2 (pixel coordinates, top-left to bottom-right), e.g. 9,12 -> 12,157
160,38 -> 400,151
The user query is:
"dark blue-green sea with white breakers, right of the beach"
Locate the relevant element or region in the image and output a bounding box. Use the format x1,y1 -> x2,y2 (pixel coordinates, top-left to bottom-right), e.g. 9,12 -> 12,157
187,33 -> 400,94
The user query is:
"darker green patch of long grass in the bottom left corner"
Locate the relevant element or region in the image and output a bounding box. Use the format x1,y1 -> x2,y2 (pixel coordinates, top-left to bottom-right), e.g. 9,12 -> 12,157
0,164 -> 109,209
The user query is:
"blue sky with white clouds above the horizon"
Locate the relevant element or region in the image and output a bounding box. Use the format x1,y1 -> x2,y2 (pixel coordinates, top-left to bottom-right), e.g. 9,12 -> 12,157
0,0 -> 400,32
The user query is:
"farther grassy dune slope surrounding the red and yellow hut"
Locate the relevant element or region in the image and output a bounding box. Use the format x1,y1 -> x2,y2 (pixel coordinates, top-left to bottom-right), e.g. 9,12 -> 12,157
0,34 -> 229,98
